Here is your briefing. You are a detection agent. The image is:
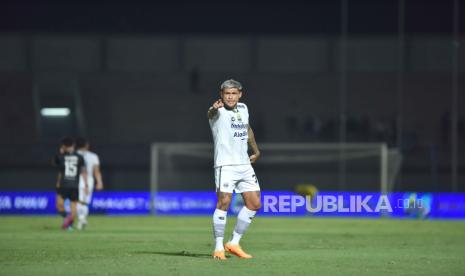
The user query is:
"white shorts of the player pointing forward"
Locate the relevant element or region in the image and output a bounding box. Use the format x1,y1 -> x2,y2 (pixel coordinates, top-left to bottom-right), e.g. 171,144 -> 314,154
215,164 -> 260,194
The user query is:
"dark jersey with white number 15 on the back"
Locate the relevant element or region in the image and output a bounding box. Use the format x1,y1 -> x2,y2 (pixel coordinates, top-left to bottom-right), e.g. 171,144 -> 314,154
54,152 -> 85,188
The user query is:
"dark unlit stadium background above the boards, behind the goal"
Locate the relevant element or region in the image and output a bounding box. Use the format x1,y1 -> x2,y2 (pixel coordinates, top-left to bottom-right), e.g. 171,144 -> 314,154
0,0 -> 465,192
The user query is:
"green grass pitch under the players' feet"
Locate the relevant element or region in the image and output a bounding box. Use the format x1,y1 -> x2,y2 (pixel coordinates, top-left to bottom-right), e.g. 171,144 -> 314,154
0,216 -> 465,276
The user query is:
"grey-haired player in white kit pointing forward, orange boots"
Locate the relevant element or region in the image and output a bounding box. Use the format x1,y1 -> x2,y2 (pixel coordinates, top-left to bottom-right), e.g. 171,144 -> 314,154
207,79 -> 261,260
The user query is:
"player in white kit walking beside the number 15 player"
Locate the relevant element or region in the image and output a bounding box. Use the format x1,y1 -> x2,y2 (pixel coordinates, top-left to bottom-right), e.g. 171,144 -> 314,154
76,138 -> 103,230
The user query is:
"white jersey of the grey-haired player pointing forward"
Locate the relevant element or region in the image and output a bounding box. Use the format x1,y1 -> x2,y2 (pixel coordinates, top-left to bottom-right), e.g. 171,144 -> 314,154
209,103 -> 250,168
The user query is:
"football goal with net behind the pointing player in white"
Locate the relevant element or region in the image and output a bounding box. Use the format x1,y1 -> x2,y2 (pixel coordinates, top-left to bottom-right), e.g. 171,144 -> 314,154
150,143 -> 402,198
